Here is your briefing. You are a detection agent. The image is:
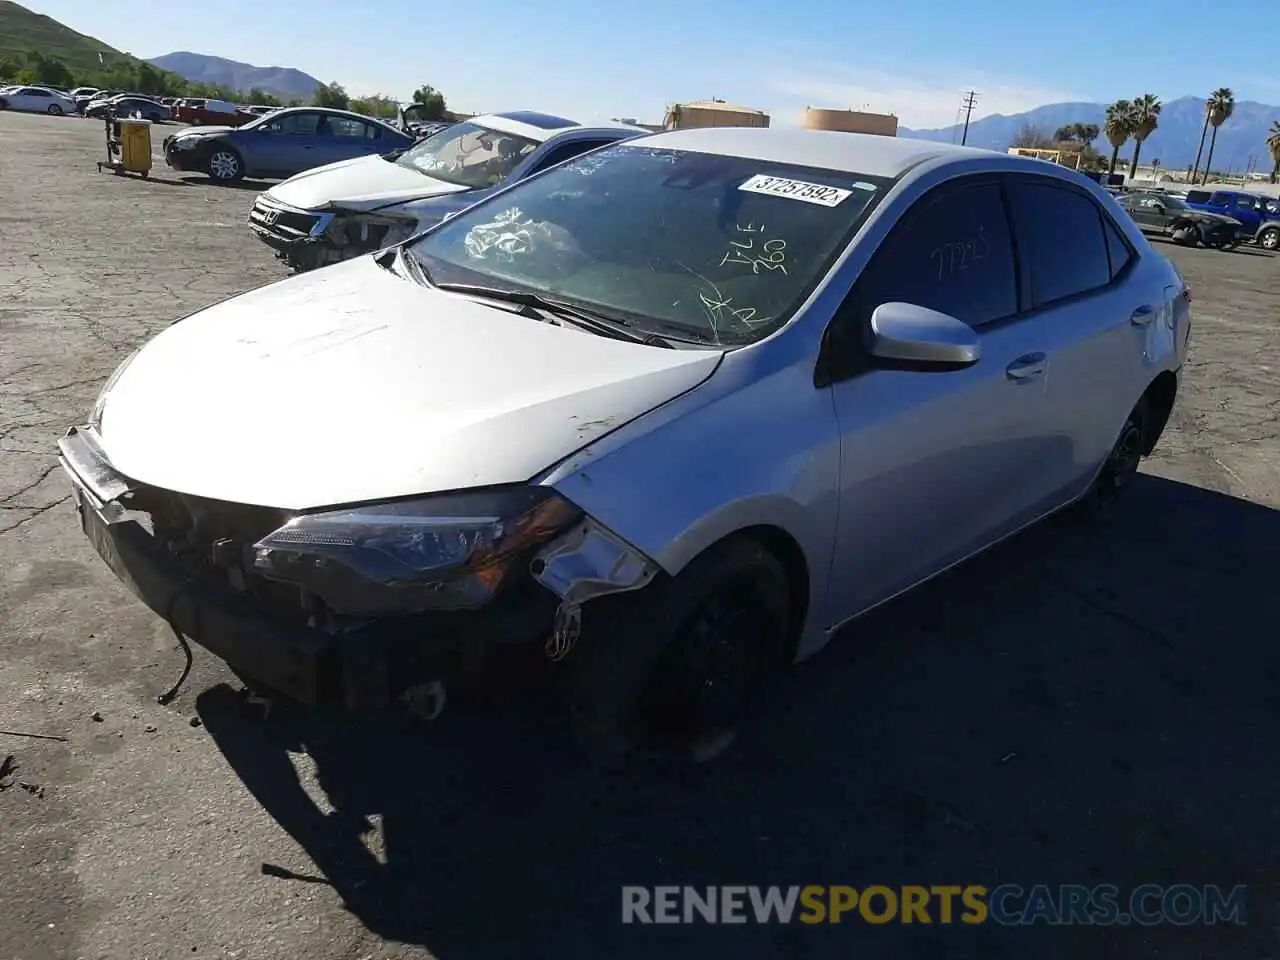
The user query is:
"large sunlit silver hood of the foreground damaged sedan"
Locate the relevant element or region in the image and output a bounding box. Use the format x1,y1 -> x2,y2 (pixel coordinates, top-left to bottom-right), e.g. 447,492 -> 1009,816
100,257 -> 721,509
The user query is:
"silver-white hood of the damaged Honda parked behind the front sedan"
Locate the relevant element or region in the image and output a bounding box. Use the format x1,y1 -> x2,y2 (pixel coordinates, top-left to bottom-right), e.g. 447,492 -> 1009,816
266,156 -> 468,212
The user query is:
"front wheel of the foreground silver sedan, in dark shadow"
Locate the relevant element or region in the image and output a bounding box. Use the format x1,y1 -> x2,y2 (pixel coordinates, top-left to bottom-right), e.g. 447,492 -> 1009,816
566,538 -> 788,767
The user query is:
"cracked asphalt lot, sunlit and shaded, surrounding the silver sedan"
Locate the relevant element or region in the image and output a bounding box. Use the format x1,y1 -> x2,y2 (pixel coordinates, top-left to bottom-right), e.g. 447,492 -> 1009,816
0,108 -> 1280,960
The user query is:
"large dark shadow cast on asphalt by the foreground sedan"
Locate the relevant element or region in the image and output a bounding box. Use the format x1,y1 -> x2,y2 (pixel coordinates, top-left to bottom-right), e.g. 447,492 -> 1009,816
197,475 -> 1280,960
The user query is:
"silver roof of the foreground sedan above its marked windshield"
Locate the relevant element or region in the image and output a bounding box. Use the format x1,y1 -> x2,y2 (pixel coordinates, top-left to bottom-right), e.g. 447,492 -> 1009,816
619,127 -> 998,178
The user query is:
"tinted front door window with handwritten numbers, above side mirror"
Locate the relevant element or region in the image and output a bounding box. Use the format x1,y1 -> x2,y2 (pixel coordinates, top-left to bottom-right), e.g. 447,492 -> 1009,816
856,180 -> 1018,326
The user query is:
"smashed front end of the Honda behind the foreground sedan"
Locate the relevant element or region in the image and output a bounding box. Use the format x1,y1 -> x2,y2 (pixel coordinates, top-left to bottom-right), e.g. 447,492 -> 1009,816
248,193 -> 417,273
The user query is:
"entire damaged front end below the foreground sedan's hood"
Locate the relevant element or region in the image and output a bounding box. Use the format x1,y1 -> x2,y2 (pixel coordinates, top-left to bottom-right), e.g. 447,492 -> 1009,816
59,426 -> 658,709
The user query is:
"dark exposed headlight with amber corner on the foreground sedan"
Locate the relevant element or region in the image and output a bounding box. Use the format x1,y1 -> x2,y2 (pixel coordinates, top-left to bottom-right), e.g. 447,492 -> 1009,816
253,486 -> 581,617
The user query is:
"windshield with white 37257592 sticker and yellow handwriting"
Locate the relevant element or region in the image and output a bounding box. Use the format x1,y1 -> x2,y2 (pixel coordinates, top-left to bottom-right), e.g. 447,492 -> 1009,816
411,145 -> 888,344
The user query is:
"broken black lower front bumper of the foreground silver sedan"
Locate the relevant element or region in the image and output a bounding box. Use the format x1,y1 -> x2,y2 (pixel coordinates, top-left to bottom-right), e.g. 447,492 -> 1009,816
59,429 -> 559,709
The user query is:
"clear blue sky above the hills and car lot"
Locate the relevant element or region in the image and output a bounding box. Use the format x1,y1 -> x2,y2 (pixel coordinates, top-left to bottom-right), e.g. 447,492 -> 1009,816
27,0 -> 1280,128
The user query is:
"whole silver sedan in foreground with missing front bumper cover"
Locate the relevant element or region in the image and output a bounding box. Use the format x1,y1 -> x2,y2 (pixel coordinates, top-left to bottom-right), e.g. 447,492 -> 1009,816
60,129 -> 1190,759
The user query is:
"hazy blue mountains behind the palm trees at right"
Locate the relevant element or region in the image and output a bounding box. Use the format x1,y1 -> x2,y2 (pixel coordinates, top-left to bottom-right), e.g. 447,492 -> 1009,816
899,97 -> 1280,172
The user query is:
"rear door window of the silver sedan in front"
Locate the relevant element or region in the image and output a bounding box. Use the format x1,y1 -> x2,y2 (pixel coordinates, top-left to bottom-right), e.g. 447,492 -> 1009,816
1009,178 -> 1112,308
